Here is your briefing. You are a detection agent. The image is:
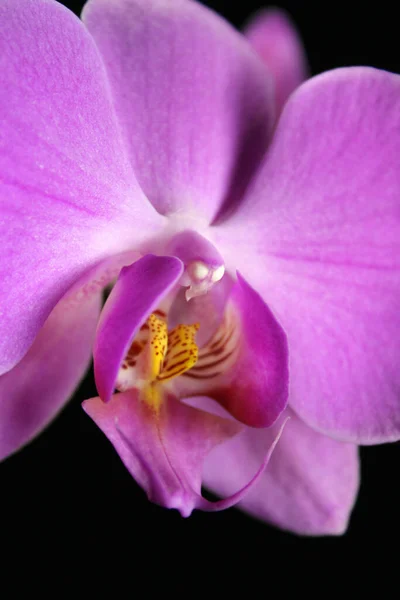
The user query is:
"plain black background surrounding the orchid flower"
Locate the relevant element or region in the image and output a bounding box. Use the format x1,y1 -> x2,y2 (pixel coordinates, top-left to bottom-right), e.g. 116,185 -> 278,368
0,0 -> 400,598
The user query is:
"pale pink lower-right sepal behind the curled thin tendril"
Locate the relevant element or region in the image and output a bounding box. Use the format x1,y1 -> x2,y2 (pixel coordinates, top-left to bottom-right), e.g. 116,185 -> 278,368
204,411 -> 359,535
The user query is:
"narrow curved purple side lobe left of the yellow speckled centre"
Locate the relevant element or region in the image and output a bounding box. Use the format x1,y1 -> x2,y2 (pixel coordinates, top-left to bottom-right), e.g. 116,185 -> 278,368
93,254 -> 183,402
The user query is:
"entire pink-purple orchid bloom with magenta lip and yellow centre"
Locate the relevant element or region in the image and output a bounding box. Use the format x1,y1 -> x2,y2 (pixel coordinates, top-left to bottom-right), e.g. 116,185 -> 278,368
0,0 -> 400,534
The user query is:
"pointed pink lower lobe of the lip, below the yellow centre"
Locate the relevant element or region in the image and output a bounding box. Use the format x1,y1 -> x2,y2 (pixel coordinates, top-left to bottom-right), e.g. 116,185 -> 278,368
83,389 -> 241,517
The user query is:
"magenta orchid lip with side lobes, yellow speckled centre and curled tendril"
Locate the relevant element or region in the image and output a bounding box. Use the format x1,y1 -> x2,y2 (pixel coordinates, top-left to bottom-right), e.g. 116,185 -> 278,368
89,246 -> 287,516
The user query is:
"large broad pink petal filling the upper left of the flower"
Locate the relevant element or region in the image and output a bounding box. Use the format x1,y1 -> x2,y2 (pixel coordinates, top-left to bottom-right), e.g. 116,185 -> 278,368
0,0 -> 162,373
